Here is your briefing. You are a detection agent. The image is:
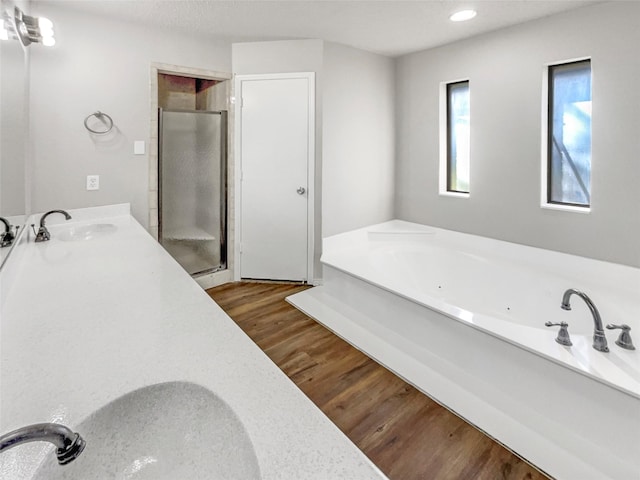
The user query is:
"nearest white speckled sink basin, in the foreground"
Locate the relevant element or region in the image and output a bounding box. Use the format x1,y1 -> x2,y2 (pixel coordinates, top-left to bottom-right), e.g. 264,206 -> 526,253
33,382 -> 260,480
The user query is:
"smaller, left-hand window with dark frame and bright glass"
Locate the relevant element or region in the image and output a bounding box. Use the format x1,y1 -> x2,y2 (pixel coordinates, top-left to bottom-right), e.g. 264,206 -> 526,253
447,81 -> 470,193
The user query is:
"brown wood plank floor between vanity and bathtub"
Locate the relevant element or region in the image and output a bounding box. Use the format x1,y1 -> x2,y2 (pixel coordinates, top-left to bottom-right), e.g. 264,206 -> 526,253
207,282 -> 548,480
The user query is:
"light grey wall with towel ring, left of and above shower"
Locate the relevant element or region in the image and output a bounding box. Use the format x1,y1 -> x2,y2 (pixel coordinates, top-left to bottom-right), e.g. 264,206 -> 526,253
30,2 -> 231,227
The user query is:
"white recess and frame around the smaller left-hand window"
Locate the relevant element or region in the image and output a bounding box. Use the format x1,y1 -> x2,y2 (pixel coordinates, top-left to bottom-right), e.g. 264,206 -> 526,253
439,78 -> 471,198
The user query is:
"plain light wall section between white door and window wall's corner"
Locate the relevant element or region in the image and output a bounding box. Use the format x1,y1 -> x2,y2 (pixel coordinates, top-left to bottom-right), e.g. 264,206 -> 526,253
322,42 -> 395,237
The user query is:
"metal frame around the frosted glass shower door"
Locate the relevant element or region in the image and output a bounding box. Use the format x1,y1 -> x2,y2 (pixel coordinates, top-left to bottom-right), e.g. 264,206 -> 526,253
158,107 -> 228,275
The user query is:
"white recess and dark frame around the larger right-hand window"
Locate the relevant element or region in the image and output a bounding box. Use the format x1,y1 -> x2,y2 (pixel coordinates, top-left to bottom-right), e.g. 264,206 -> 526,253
540,57 -> 593,213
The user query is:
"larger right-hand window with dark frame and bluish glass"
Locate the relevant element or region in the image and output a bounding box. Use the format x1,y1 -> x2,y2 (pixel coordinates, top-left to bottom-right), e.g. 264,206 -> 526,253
547,60 -> 591,207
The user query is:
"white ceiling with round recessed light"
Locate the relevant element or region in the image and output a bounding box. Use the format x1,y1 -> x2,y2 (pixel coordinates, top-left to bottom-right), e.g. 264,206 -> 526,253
37,0 -> 598,57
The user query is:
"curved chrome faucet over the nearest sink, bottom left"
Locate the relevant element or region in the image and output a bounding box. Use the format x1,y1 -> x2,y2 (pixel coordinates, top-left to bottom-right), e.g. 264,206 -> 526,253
0,423 -> 86,465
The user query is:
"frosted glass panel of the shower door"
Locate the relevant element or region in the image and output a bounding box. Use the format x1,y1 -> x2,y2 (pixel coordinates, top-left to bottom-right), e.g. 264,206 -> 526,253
158,108 -> 227,275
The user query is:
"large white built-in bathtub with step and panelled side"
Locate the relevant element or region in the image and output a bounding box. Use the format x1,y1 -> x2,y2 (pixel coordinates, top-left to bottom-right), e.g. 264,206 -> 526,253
290,221 -> 640,480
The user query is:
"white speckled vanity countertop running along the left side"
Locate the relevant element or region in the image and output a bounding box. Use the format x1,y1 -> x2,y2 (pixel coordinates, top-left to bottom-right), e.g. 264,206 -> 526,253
0,205 -> 385,480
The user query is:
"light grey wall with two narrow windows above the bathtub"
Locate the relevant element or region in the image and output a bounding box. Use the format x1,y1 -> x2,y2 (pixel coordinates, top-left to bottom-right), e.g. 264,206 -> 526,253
396,2 -> 640,266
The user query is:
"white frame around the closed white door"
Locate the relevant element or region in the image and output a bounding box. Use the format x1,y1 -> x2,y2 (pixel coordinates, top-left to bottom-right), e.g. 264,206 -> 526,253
232,72 -> 316,285
